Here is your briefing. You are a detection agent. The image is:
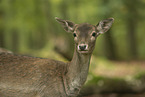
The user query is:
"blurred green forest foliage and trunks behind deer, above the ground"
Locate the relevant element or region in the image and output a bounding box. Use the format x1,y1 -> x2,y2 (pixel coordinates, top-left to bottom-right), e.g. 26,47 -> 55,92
0,0 -> 145,60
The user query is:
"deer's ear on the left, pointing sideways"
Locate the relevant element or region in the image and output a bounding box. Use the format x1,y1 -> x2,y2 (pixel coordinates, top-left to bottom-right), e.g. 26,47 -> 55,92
55,17 -> 75,32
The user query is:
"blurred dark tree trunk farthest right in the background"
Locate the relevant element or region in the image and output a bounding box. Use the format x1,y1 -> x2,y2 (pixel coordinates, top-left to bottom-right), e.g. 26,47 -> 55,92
124,0 -> 140,59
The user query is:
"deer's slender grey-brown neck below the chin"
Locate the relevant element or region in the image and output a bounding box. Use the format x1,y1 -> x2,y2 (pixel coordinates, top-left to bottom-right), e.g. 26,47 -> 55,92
67,46 -> 91,94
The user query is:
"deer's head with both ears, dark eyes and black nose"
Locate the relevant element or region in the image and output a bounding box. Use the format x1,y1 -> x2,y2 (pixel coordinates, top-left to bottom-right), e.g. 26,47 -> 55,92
56,17 -> 114,54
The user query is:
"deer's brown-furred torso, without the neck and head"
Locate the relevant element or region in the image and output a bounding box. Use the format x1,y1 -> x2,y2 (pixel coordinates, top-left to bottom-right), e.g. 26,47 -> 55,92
0,53 -> 66,97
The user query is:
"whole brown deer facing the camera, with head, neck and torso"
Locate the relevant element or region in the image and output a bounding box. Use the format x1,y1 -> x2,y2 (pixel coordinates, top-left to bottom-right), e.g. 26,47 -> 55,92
0,18 -> 113,97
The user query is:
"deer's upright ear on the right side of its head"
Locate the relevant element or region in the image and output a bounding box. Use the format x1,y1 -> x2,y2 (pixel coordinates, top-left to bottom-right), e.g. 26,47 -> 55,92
96,18 -> 114,34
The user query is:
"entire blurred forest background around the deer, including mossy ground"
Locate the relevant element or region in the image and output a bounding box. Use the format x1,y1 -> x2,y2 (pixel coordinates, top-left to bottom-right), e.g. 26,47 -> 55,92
0,0 -> 145,93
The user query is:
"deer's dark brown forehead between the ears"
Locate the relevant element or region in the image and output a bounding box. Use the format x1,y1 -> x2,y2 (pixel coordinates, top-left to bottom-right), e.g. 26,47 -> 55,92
76,23 -> 94,33
